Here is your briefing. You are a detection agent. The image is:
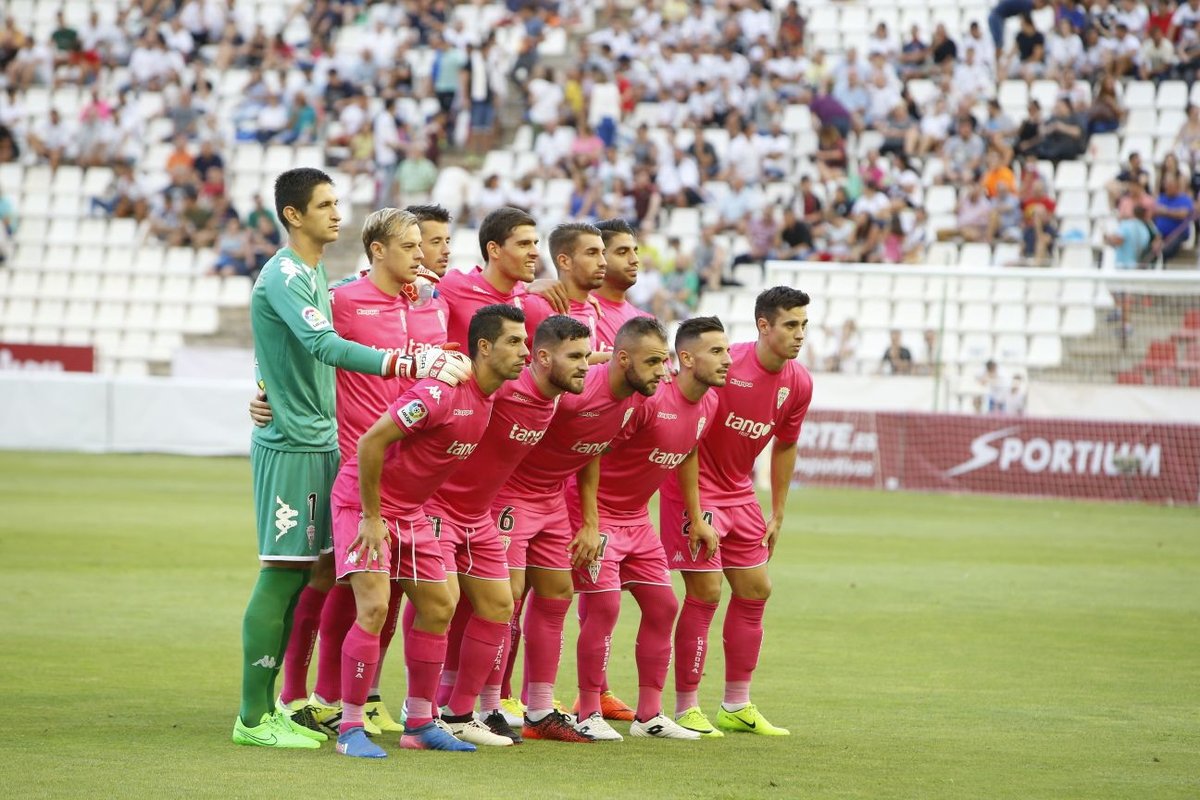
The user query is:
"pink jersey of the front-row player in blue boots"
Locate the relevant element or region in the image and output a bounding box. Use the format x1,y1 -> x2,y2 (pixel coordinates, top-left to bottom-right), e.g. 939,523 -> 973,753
332,378 -> 492,517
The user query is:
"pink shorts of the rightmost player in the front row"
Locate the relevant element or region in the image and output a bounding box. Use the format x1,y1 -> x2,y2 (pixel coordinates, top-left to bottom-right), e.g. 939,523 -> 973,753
659,495 -> 770,572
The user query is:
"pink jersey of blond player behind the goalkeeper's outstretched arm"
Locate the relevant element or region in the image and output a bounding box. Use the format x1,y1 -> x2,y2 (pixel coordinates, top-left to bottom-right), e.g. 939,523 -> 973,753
329,277 -> 410,461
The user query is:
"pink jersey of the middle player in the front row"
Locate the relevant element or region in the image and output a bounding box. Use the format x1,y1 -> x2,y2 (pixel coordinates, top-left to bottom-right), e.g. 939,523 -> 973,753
499,363 -> 646,505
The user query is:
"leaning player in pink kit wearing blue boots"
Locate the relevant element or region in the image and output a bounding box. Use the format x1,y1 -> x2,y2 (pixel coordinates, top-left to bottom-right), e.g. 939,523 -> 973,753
331,305 -> 529,758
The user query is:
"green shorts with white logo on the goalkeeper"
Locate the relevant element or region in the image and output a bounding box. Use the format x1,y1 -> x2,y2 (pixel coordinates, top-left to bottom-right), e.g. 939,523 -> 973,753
250,443 -> 340,561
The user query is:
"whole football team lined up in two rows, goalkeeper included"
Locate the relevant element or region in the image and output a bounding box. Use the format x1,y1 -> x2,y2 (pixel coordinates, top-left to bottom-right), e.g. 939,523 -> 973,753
233,169 -> 812,758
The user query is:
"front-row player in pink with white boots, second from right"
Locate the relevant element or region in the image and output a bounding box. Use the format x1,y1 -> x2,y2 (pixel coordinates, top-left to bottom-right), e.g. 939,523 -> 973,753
568,317 -> 730,741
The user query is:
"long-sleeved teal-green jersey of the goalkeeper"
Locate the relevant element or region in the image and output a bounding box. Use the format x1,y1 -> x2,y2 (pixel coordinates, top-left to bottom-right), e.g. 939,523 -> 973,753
250,247 -> 388,452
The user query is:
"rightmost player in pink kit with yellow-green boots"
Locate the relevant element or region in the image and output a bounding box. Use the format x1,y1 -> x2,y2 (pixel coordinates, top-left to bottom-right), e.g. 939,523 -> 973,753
660,287 -> 812,736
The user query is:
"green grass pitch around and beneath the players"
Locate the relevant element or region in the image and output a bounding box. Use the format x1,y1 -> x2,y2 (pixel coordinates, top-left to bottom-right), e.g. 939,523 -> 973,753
0,453 -> 1200,800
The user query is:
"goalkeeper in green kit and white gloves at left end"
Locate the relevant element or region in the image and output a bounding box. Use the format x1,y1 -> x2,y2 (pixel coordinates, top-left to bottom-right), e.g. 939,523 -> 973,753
233,168 -> 470,748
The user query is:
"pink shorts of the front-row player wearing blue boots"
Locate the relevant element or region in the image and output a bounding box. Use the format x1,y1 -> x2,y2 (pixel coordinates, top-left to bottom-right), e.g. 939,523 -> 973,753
334,505 -> 446,583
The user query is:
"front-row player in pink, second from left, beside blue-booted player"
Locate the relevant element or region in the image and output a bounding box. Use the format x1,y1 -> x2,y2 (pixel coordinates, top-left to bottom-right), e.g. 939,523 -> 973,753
425,314 -> 592,745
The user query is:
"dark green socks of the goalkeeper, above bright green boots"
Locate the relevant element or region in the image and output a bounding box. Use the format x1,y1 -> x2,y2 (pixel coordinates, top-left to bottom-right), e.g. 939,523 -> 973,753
240,567 -> 308,726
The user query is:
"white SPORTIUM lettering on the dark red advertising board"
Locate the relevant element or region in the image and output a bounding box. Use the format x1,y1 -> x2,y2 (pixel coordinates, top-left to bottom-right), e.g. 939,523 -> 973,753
946,426 -> 1163,477
